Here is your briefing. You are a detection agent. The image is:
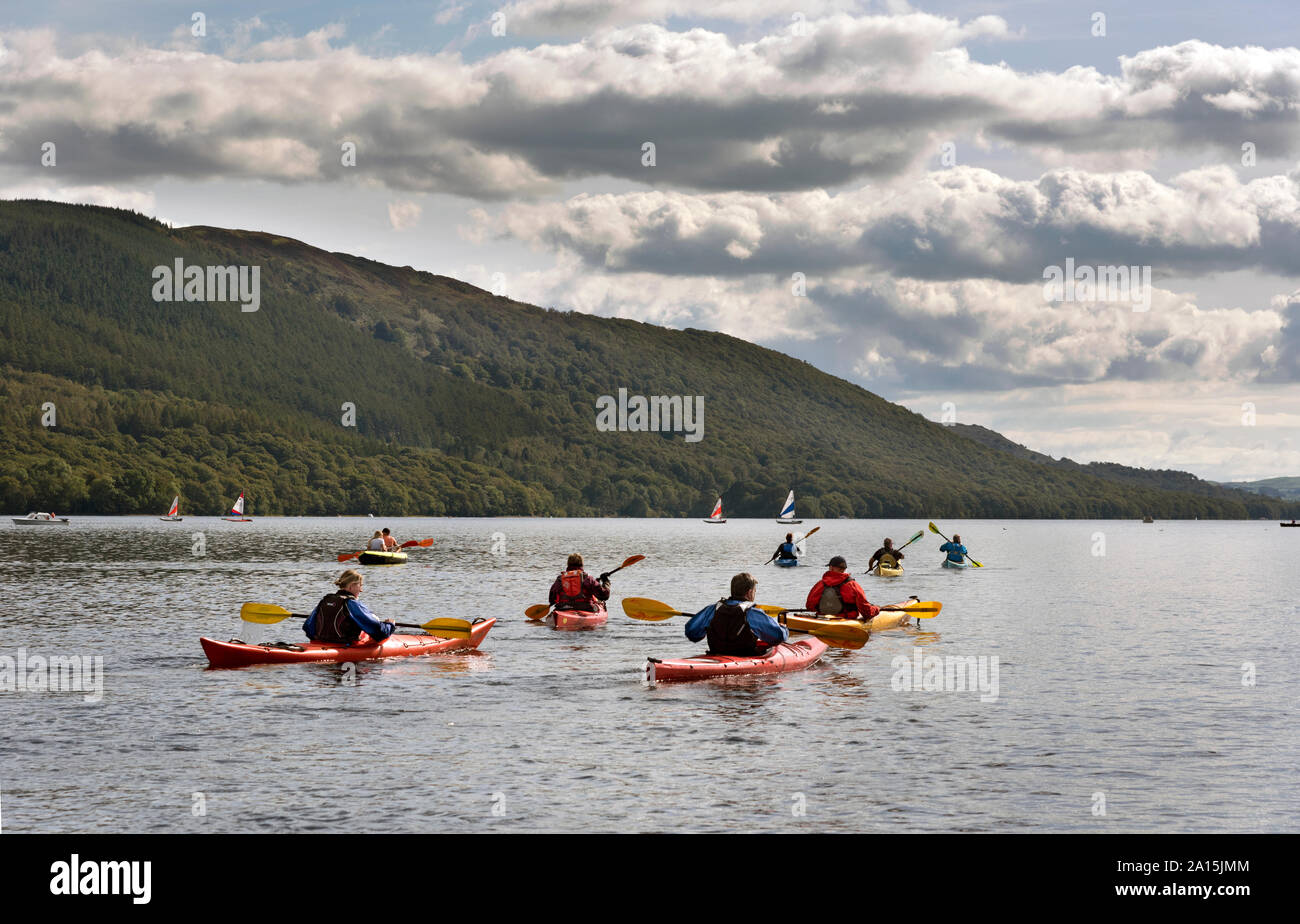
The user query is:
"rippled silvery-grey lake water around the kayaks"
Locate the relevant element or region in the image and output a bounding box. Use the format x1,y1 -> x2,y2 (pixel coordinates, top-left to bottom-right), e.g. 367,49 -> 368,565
0,517 -> 1300,833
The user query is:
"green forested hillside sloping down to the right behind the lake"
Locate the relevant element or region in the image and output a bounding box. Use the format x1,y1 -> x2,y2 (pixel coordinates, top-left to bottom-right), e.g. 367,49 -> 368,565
0,201 -> 1300,519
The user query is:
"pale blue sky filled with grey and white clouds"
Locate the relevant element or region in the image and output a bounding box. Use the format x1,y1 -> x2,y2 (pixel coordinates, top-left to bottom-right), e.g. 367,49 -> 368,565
0,0 -> 1300,480
